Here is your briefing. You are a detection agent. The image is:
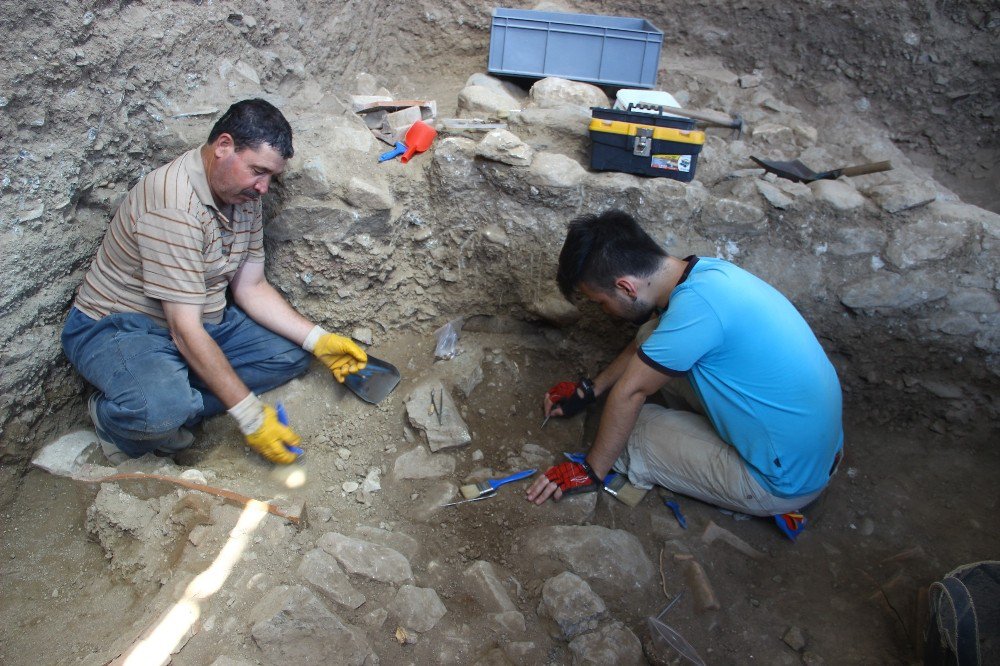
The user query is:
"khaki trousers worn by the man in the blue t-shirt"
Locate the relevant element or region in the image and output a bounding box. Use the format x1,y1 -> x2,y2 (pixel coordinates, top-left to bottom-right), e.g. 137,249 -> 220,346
614,320 -> 822,516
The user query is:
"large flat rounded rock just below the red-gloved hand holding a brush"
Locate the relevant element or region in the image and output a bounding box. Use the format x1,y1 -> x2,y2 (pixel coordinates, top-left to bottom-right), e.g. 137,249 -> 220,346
519,528 -> 655,594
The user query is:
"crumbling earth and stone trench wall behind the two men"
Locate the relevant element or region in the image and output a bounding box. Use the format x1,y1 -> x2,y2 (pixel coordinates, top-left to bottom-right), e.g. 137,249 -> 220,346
0,0 -> 1000,461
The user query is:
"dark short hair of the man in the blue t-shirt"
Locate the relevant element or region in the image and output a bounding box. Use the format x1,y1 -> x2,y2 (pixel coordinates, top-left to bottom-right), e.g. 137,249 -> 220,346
556,210 -> 670,298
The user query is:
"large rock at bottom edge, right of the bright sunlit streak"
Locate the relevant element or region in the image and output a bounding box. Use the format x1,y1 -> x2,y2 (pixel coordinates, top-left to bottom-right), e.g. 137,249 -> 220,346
250,585 -> 376,666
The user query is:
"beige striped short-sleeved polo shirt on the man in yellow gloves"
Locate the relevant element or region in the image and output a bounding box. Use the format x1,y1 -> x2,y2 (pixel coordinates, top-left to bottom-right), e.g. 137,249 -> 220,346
74,148 -> 264,327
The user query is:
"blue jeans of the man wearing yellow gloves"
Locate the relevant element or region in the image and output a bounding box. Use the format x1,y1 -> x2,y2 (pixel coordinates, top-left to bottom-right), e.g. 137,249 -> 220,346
62,305 -> 310,457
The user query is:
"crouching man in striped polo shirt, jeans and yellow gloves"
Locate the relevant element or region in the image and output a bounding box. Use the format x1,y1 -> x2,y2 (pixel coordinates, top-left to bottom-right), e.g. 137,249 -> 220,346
62,99 -> 367,464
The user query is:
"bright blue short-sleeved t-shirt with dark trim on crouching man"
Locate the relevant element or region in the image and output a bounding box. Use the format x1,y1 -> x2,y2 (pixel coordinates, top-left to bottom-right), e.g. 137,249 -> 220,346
639,257 -> 844,497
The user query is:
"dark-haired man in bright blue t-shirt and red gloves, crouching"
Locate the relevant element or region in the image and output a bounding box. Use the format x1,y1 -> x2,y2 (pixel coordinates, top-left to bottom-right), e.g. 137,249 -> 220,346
527,211 -> 844,516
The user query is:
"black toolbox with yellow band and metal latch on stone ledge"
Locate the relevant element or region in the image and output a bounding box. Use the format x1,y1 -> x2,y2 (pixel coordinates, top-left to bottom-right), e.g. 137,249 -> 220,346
590,104 -> 705,183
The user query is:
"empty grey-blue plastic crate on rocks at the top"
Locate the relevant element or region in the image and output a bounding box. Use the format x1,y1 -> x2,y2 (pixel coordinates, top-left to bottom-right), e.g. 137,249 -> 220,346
487,7 -> 663,88
